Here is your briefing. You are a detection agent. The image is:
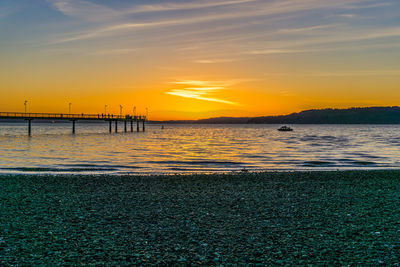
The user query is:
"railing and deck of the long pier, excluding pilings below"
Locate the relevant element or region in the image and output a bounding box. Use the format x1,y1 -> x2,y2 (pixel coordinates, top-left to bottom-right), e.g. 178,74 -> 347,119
0,112 -> 146,121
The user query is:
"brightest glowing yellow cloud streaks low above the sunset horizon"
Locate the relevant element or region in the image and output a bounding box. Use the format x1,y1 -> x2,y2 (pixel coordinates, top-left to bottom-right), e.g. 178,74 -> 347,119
166,80 -> 239,106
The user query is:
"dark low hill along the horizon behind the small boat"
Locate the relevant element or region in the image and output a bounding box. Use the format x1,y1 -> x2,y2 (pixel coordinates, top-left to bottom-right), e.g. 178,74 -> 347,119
151,107 -> 400,124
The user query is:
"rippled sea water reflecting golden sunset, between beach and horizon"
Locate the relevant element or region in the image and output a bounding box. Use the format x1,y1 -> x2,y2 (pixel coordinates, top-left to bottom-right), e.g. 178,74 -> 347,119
0,122 -> 400,174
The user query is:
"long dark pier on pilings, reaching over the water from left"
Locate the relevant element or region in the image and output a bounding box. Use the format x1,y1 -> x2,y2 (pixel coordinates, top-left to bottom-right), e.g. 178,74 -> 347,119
0,112 -> 146,136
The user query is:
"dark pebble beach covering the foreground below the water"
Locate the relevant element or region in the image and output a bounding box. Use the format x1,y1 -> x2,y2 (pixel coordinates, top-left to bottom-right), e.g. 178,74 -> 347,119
0,170 -> 400,266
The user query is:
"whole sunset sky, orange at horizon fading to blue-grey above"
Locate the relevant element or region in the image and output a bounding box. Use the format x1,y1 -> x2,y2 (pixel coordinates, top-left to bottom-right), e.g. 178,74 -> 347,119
0,0 -> 400,120
